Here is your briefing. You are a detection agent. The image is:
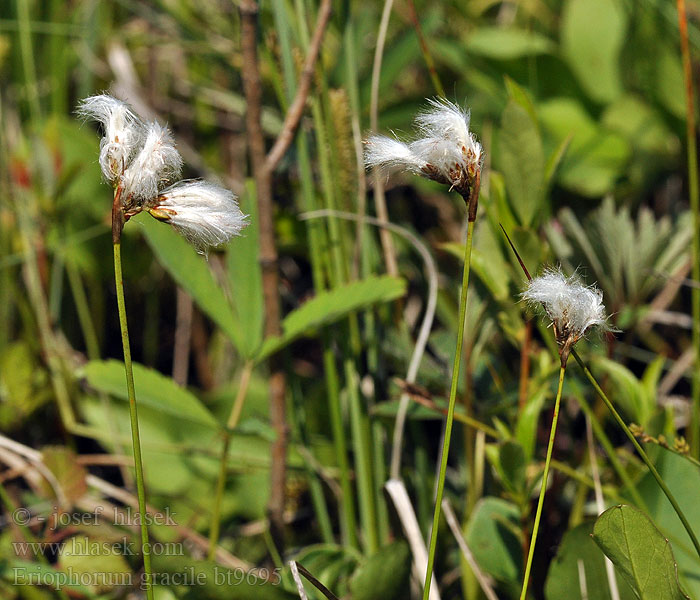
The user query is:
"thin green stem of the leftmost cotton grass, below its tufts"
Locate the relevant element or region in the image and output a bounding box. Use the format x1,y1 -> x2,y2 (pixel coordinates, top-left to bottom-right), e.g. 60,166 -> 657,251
113,240 -> 153,600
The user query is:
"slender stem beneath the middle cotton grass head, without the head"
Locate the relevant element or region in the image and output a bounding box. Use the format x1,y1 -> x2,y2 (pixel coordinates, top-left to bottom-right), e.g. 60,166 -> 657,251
423,172 -> 481,600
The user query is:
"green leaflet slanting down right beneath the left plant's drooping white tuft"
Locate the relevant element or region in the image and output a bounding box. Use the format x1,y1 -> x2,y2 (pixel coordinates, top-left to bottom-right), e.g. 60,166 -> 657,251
135,215 -> 245,348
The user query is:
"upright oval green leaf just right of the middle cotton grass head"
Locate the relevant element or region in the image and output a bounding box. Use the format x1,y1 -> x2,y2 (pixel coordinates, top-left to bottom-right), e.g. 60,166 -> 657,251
498,100 -> 548,227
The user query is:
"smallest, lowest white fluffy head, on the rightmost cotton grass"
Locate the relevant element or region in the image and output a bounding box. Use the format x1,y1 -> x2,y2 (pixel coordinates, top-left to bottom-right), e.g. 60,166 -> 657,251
522,269 -> 610,349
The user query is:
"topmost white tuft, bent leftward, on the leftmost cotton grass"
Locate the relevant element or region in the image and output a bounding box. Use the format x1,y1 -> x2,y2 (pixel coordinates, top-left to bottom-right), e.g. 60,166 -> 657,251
77,94 -> 145,185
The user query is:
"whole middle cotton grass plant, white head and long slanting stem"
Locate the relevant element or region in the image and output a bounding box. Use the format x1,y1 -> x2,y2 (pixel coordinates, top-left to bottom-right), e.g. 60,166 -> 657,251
365,100 -> 484,600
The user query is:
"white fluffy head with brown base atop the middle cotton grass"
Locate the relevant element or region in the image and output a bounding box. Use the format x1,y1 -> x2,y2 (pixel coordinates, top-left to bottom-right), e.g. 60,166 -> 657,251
365,100 -> 484,197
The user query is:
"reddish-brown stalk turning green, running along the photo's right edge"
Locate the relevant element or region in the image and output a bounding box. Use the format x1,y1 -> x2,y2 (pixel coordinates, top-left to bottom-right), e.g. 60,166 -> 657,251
676,0 -> 700,458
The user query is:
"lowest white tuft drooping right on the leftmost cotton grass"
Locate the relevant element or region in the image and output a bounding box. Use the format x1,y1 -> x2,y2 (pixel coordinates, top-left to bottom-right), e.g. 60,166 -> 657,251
151,181 -> 248,254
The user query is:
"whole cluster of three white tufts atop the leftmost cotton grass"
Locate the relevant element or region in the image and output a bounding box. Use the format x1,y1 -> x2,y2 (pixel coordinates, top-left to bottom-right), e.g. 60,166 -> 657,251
78,94 -> 248,254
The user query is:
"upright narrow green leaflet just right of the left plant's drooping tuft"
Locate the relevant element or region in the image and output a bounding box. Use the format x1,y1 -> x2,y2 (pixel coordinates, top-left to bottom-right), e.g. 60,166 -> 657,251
226,180 -> 264,358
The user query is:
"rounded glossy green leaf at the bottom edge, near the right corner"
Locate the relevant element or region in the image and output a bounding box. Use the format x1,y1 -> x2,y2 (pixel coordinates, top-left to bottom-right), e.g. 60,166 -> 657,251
593,505 -> 689,600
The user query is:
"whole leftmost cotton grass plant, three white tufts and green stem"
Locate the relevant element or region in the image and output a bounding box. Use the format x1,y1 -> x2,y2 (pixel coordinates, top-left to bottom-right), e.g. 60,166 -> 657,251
78,94 -> 246,600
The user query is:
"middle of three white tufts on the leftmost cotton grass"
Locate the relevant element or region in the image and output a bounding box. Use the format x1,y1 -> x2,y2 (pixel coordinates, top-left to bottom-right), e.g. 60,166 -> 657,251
122,121 -> 182,206
